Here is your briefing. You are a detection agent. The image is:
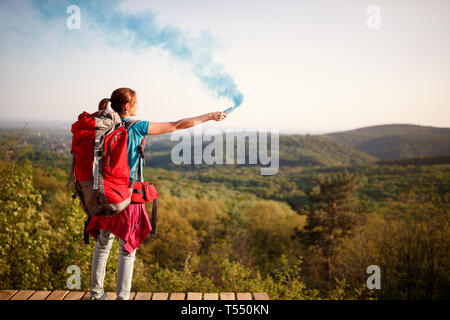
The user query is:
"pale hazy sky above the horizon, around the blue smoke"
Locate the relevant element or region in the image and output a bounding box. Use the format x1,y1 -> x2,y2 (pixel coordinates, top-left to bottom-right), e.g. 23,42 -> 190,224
0,0 -> 450,133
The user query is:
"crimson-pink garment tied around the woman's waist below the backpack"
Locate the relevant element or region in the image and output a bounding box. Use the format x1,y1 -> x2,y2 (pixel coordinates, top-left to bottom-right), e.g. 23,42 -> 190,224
86,203 -> 152,254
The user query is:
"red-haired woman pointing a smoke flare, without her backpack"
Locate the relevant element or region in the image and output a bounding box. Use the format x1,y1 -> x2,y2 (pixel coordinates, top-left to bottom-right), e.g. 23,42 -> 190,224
86,88 -> 226,300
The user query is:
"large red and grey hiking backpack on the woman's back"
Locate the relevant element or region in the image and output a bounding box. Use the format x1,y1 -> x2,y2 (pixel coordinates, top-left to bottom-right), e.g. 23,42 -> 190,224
67,110 -> 138,216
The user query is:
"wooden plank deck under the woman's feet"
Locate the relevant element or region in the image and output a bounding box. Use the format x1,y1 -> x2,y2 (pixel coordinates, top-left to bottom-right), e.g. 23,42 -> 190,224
0,290 -> 269,300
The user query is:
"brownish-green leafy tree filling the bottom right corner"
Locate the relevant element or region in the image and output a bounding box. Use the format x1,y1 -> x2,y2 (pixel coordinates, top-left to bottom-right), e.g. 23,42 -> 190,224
336,188 -> 450,299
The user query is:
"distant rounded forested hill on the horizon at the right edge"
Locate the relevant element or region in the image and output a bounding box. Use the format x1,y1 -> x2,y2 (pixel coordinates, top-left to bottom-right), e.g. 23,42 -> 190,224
325,124 -> 450,159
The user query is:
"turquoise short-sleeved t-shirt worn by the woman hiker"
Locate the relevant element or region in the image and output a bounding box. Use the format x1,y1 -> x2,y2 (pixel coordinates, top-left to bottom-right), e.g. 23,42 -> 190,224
122,118 -> 149,181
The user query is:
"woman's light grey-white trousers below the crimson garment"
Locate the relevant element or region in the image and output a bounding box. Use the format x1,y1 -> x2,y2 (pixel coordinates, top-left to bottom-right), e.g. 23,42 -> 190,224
91,229 -> 136,300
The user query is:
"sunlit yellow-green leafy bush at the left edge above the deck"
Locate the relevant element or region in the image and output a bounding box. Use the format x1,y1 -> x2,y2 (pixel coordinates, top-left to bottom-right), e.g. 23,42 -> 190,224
0,161 -> 52,290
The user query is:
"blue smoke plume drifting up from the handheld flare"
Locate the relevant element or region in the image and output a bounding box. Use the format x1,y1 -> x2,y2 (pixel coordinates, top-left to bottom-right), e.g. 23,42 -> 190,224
33,0 -> 244,107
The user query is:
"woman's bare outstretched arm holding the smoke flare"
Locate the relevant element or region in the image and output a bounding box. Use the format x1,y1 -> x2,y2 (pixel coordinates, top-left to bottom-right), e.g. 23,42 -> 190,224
148,111 -> 227,134
